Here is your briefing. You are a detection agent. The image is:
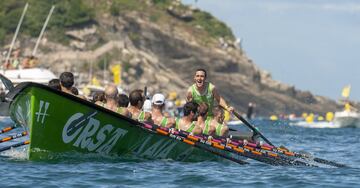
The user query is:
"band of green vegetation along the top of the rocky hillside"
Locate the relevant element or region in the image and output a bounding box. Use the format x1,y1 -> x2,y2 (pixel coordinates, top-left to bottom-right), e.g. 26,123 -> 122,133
0,0 -> 234,46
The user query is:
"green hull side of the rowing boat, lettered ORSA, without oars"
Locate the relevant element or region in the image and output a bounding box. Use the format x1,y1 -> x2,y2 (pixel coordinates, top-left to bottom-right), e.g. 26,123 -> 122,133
10,83 -> 239,161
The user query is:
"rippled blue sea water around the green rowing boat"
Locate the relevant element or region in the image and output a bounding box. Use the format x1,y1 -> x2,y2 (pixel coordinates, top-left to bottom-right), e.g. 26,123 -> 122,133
0,119 -> 360,188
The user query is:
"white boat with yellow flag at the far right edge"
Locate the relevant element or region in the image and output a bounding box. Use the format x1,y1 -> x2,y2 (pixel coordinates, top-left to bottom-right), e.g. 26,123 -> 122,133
334,85 -> 360,128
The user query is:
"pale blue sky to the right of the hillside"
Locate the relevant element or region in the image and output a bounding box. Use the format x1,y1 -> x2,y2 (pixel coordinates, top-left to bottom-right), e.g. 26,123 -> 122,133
183,0 -> 360,101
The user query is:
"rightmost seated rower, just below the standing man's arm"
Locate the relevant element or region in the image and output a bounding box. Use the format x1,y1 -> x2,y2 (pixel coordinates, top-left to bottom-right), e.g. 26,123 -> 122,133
211,106 -> 229,136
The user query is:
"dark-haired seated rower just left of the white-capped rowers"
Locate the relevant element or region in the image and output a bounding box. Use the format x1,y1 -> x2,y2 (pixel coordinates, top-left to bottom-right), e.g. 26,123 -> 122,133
128,89 -> 151,122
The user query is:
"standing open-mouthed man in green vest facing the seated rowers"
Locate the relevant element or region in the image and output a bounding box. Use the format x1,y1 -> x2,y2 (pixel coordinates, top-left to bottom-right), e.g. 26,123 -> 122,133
186,69 -> 234,117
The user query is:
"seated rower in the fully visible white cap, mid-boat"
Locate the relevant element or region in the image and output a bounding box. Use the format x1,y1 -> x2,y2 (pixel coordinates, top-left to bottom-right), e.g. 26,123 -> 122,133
151,93 -> 175,128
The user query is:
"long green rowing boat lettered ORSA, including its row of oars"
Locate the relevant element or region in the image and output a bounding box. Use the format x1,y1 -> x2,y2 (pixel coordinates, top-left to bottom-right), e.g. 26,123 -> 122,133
0,74 -> 345,167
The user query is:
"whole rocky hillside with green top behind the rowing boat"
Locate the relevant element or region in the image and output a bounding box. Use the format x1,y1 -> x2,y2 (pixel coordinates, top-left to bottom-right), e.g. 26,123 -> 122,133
0,0 -> 339,115
